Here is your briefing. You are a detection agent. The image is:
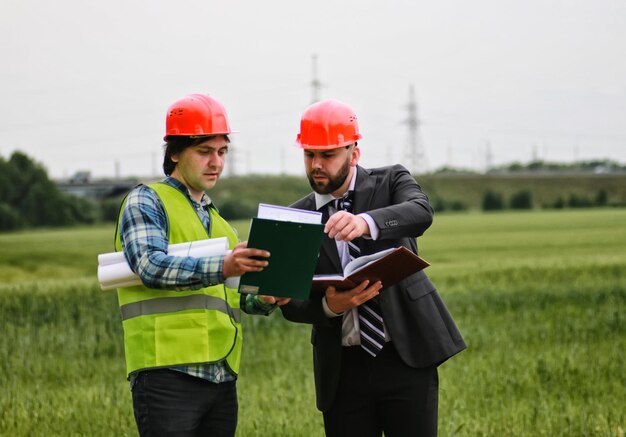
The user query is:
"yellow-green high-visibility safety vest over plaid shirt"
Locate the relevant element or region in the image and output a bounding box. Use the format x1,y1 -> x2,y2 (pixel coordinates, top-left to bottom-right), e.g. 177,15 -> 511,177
115,183 -> 243,375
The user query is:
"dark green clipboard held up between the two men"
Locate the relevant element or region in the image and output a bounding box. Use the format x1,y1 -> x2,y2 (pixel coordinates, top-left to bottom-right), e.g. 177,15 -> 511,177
239,217 -> 324,300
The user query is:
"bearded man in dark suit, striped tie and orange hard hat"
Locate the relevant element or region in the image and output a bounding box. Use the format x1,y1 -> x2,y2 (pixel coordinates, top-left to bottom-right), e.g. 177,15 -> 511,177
281,100 -> 466,437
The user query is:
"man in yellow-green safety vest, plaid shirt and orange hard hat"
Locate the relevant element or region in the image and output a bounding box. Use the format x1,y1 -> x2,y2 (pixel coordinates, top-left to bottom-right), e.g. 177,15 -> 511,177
115,94 -> 288,437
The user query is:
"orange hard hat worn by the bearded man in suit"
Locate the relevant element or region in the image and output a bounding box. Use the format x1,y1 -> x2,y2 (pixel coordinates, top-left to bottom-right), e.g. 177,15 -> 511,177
296,100 -> 361,150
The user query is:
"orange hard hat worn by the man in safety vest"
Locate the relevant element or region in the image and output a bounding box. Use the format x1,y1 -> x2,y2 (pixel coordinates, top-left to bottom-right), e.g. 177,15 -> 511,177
164,94 -> 232,139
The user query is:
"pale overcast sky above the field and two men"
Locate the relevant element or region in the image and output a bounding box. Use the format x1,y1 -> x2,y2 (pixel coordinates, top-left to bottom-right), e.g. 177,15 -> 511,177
0,0 -> 626,179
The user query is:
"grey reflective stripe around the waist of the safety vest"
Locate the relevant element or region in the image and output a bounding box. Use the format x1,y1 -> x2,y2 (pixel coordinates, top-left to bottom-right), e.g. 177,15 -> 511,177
120,294 -> 241,323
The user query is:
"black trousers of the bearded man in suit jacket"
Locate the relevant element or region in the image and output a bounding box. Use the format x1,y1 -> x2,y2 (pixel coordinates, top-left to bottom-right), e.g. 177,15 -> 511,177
324,343 -> 439,437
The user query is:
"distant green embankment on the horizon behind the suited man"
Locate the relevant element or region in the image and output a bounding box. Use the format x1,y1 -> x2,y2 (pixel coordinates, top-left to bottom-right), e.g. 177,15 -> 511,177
209,173 -> 626,218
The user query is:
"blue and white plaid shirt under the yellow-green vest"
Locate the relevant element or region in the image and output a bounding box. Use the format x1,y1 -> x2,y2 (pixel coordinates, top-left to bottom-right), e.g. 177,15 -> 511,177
120,177 -> 276,384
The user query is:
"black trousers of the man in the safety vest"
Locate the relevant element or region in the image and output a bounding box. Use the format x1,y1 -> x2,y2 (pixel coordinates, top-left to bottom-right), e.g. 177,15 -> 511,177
132,369 -> 238,437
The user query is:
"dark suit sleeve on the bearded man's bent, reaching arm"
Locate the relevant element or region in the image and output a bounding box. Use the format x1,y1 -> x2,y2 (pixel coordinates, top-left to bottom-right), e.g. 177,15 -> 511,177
363,165 -> 433,240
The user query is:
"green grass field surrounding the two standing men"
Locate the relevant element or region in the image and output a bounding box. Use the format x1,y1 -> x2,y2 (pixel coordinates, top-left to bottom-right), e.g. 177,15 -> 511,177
0,209 -> 626,437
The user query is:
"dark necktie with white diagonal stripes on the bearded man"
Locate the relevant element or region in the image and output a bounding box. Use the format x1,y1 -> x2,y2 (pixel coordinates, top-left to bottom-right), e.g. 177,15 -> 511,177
335,191 -> 385,357
